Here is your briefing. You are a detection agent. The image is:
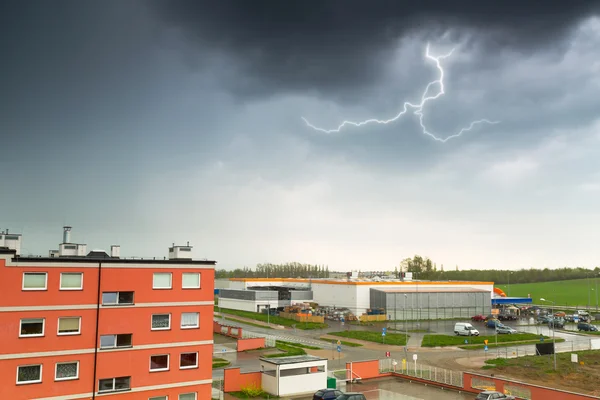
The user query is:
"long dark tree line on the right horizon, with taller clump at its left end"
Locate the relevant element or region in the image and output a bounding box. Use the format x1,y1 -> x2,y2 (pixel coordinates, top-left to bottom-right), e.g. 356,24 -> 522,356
394,255 -> 600,284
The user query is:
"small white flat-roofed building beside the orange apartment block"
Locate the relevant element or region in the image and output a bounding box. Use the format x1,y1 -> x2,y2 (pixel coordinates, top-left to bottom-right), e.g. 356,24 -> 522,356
260,355 -> 327,397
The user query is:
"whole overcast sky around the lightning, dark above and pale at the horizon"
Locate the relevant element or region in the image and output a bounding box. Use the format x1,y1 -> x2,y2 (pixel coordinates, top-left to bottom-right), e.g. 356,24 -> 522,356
0,0 -> 600,270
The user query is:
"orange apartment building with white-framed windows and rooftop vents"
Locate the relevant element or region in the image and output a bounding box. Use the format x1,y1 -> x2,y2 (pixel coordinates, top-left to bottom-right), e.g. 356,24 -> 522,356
0,227 -> 216,400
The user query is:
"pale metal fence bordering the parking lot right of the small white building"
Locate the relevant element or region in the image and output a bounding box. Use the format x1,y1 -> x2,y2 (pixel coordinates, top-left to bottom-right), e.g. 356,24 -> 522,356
379,358 -> 463,388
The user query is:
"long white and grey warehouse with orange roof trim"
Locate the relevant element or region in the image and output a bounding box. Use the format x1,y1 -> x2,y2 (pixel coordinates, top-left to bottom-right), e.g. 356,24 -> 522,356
216,278 -> 494,320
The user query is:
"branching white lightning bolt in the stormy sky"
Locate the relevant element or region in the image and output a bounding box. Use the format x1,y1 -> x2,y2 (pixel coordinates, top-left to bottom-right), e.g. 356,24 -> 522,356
302,43 -> 500,143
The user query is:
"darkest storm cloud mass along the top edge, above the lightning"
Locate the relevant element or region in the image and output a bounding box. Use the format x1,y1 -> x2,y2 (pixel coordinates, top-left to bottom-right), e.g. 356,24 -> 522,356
152,0 -> 600,92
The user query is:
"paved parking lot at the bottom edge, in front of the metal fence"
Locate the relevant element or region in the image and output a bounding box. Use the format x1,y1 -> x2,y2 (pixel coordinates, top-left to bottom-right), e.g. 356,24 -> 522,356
294,378 -> 475,400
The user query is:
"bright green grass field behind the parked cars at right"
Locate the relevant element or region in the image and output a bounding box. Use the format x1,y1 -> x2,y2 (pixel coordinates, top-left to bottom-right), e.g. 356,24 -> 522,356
496,279 -> 600,309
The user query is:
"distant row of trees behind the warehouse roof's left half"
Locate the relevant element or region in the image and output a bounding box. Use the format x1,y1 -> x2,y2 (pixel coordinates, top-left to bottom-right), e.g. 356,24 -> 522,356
215,262 -> 329,279
